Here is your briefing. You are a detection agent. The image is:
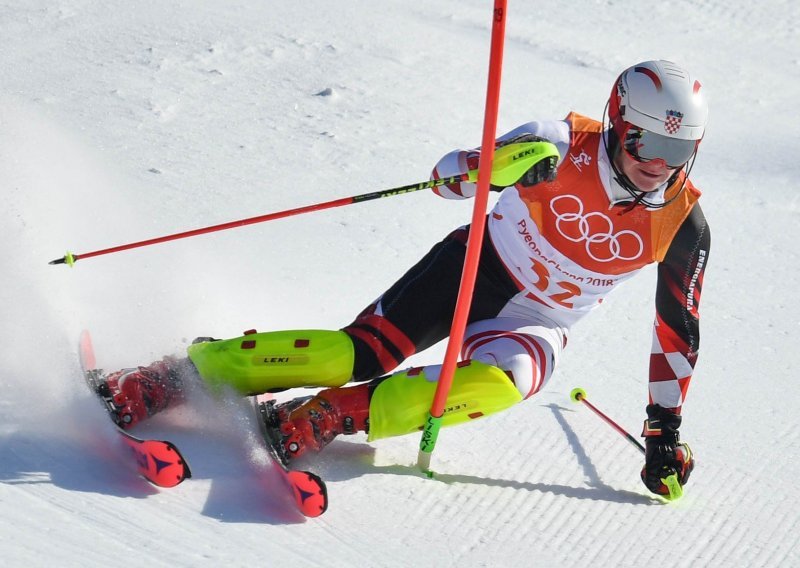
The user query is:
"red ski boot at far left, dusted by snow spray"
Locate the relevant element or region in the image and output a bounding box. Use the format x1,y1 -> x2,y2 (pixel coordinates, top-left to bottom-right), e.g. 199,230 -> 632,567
86,357 -> 183,430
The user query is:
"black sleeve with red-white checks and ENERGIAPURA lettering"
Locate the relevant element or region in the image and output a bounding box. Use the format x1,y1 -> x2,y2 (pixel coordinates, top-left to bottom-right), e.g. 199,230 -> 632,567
649,204 -> 711,413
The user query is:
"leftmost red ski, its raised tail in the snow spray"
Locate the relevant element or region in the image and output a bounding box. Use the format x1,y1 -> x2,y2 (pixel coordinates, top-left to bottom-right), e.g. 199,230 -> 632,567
78,331 -> 192,487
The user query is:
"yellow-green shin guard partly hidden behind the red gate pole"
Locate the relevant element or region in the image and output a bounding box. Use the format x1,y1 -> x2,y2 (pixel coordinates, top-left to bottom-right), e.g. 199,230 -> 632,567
369,361 -> 522,441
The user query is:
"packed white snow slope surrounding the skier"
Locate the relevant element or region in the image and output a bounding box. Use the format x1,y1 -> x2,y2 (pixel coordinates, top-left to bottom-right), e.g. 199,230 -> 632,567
0,0 -> 800,567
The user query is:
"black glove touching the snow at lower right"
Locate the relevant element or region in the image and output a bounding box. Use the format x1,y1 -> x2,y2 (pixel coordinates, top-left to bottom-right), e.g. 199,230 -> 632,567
642,404 -> 694,496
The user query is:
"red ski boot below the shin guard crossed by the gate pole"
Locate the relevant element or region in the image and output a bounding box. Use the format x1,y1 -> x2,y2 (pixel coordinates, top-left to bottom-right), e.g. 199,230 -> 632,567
259,384 -> 369,465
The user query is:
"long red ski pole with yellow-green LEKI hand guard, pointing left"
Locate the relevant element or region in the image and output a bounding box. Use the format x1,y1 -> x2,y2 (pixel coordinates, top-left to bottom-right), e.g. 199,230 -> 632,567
48,142 -> 558,266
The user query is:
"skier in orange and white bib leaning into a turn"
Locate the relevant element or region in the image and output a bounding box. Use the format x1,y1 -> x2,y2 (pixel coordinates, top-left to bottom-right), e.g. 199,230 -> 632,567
98,61 -> 710,495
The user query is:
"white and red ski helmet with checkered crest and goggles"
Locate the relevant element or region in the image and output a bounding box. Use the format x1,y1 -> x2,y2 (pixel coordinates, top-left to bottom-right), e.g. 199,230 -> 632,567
608,60 -> 708,167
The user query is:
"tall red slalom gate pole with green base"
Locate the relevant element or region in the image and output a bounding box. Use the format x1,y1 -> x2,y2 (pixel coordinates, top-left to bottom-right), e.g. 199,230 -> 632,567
417,0 -> 506,476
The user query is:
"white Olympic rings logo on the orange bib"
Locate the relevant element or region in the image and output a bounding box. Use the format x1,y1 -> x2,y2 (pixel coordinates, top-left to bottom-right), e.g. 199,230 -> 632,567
550,195 -> 644,262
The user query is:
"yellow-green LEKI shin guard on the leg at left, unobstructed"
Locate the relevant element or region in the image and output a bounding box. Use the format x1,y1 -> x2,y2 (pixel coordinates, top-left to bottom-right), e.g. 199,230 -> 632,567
188,330 -> 354,394
